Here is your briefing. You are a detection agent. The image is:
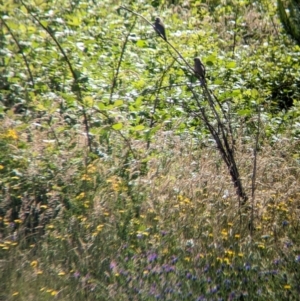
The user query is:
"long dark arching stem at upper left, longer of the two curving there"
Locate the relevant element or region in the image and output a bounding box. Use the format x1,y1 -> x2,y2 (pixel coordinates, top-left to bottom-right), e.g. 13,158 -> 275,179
21,1 -> 92,151
